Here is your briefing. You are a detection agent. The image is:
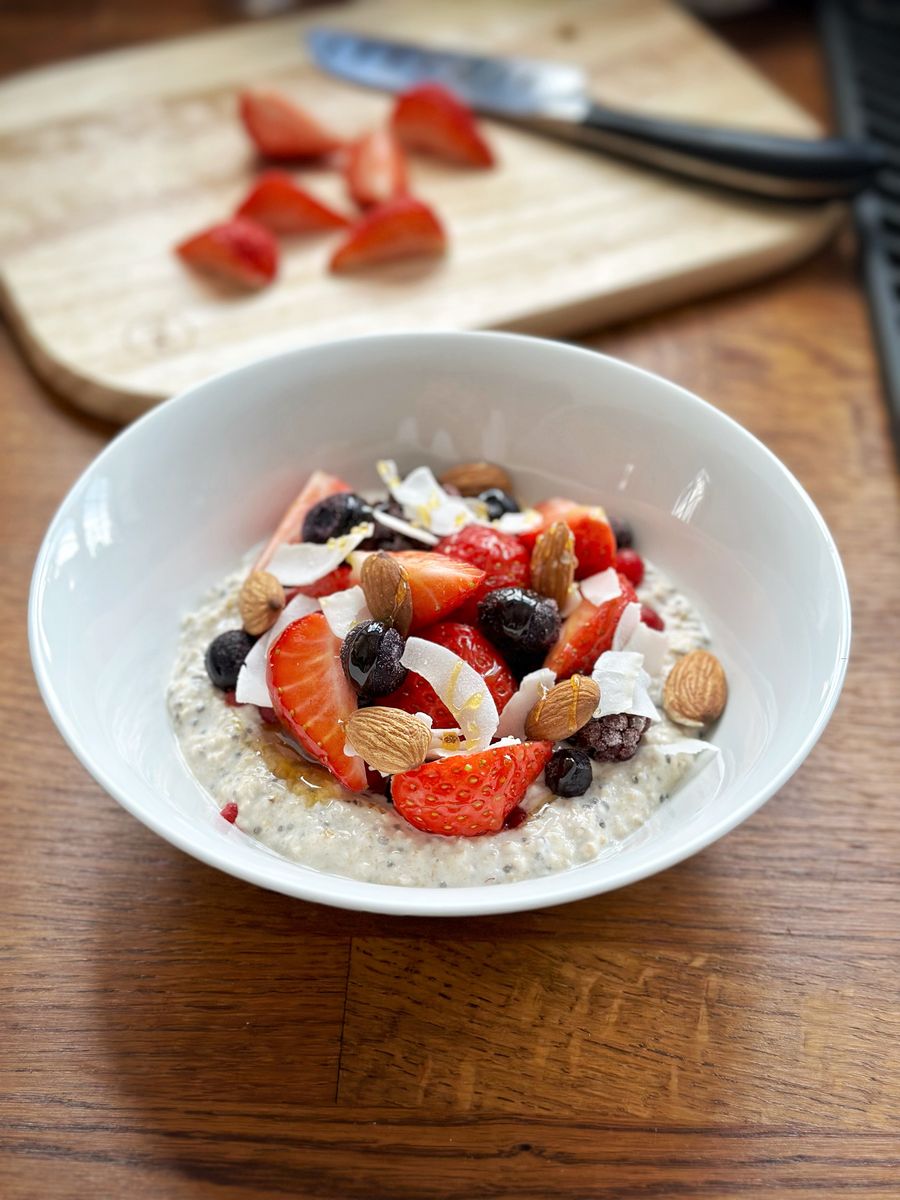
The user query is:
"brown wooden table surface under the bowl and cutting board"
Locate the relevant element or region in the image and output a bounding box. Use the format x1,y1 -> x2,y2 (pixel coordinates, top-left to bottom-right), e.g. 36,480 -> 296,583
0,0 -> 900,1200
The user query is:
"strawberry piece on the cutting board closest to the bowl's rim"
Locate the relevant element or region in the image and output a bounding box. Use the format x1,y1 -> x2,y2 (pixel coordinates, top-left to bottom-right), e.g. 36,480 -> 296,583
330,196 -> 446,271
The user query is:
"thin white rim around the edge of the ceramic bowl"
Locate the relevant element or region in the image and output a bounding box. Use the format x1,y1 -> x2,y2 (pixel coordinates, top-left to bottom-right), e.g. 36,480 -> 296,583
28,330 -> 851,917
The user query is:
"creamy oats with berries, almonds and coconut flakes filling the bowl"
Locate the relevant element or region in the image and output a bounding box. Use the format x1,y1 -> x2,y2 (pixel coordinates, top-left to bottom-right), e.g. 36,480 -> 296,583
168,462 -> 726,887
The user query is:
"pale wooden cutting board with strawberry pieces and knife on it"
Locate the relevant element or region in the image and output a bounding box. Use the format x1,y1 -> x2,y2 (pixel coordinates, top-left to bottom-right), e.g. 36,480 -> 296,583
0,0 -> 838,420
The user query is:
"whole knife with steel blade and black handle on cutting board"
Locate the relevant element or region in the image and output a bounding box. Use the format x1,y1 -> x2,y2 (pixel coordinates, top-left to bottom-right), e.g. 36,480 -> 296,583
307,29 -> 884,200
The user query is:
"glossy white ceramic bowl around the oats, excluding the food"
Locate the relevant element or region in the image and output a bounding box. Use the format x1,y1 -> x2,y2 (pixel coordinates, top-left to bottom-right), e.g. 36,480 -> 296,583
29,334 -> 850,916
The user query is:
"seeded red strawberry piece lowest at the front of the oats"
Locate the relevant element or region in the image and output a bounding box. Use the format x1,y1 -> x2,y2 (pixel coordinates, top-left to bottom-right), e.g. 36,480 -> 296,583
391,742 -> 553,838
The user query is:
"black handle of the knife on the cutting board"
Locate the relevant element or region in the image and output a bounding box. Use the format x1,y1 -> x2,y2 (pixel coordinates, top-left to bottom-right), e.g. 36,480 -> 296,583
553,104 -> 884,200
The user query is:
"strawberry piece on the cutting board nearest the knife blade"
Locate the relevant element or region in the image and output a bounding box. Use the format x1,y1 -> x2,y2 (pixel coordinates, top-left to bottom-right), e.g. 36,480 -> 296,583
391,83 -> 494,167
